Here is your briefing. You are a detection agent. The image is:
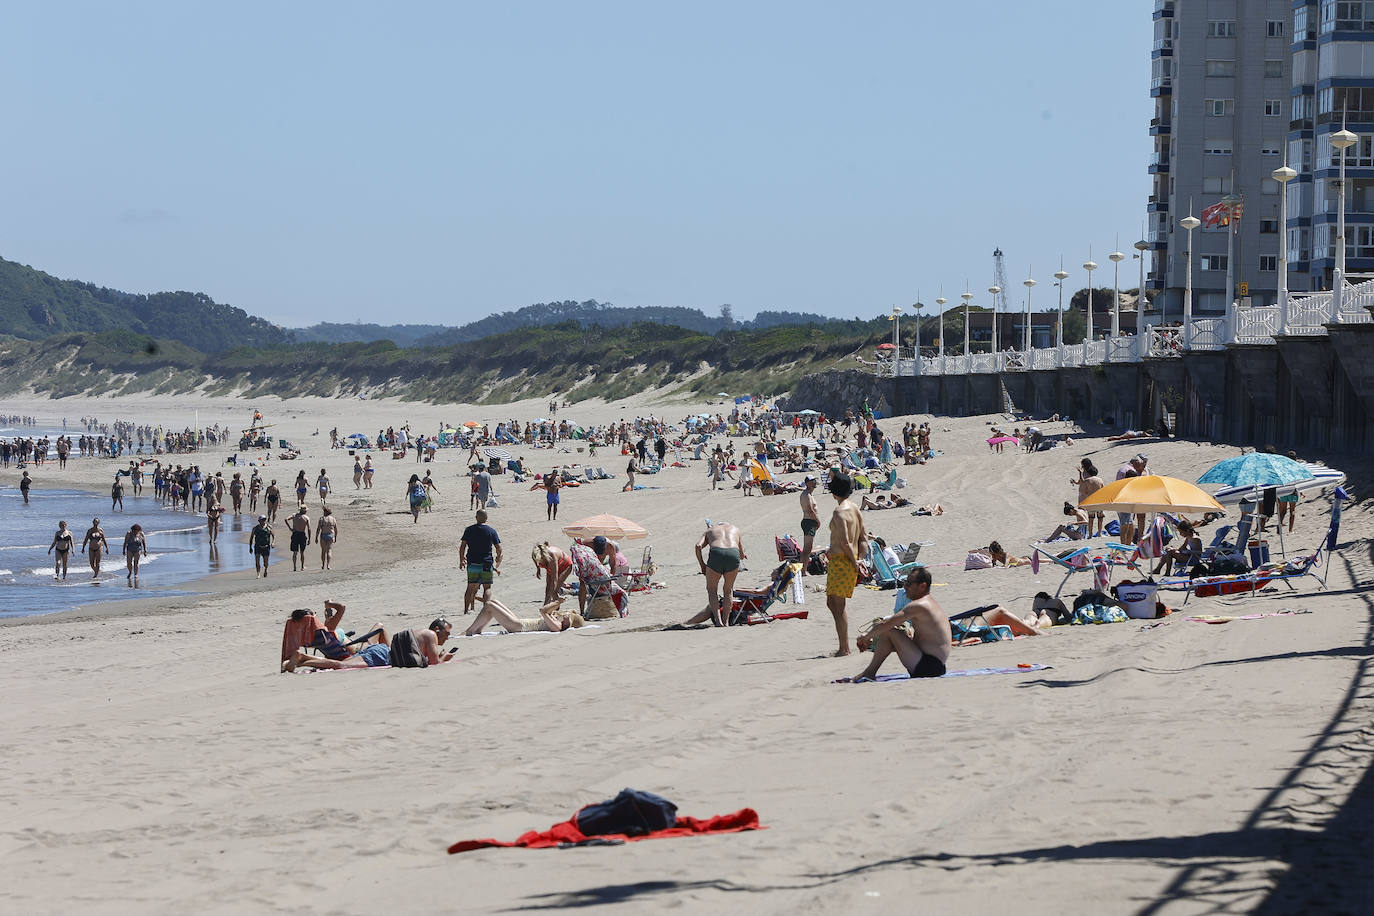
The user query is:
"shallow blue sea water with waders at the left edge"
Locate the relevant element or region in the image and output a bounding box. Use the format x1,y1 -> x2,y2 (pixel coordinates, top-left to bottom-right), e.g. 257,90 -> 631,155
0,483 -> 254,617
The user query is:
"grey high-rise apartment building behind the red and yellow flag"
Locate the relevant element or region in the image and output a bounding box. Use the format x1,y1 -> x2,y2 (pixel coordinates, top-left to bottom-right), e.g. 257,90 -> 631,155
1146,0 -> 1297,319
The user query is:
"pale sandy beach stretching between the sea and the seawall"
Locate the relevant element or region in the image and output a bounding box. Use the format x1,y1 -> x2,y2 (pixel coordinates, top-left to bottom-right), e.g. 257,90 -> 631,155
0,394 -> 1374,913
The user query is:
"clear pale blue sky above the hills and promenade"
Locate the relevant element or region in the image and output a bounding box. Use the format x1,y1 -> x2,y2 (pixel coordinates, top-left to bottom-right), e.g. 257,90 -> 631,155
0,0 -> 1151,325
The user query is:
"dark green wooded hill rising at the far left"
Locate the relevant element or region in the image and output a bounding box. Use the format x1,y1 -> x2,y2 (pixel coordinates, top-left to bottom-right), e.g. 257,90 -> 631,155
0,258 -> 290,353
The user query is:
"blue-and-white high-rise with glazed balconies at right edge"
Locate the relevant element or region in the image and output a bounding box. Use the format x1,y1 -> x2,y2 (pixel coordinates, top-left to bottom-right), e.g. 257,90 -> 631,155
1287,0 -> 1374,290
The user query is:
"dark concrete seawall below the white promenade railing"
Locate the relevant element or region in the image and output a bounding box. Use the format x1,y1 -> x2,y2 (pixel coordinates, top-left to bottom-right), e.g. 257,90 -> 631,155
782,324 -> 1374,452
